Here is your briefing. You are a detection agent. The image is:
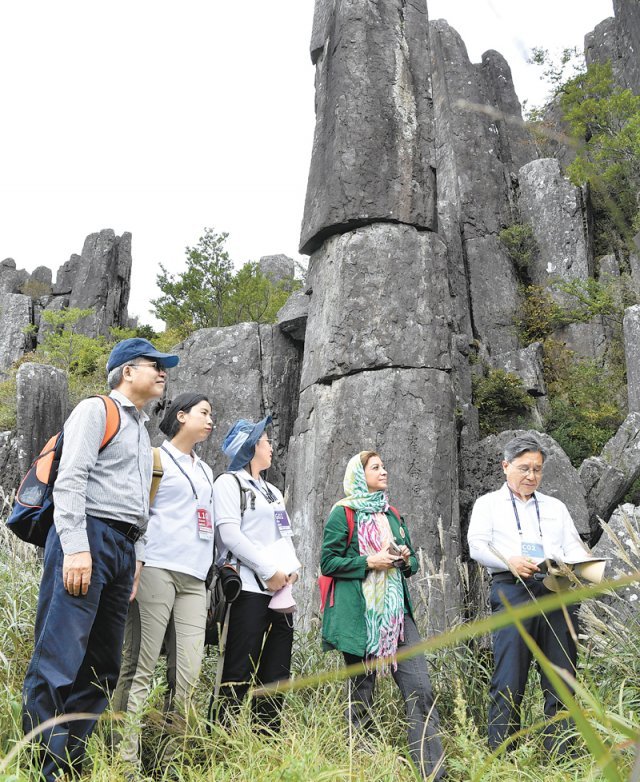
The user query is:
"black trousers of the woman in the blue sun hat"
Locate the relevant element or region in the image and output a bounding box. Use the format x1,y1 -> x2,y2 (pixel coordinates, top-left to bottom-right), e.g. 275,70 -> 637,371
219,591 -> 293,731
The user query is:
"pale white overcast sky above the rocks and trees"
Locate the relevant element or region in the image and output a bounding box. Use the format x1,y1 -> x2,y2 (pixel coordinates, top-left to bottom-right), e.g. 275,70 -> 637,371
0,0 -> 613,325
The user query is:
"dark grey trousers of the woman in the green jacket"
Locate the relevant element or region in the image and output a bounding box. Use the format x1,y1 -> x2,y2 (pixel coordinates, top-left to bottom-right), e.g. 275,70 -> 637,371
343,614 -> 445,780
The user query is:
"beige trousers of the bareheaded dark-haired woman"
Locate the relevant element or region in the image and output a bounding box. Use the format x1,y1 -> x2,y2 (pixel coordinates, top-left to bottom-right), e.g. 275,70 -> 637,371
112,567 -> 207,762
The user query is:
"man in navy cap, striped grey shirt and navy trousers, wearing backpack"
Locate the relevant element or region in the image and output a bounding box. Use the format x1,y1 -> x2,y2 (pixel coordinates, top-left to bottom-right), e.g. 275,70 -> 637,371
23,338 -> 179,782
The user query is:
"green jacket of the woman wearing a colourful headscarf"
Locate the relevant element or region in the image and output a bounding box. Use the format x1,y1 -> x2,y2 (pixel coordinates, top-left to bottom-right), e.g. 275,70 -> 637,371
320,506 -> 418,657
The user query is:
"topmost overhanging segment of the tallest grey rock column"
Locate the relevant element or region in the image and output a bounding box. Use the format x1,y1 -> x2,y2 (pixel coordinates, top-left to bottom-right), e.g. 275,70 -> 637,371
300,0 -> 436,253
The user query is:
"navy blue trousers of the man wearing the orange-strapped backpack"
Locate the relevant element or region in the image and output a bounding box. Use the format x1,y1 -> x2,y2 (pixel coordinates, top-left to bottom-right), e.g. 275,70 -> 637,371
22,516 -> 136,782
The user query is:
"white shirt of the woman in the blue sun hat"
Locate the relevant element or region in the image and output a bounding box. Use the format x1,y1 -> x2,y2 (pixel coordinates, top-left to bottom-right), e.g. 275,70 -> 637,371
213,470 -> 293,595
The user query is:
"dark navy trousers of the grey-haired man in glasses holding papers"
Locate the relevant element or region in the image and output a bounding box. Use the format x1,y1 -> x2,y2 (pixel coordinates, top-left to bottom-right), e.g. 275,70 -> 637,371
489,579 -> 577,753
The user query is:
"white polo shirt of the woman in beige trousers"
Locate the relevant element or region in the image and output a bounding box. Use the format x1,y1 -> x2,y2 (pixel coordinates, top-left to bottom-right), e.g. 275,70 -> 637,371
144,440 -> 213,581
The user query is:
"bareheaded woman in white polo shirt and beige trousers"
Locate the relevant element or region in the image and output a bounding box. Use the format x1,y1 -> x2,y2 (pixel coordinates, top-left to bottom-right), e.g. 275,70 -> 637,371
112,394 -> 213,764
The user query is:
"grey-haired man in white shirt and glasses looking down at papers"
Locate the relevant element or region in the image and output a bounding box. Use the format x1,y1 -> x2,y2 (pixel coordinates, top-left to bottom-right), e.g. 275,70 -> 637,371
468,434 -> 589,752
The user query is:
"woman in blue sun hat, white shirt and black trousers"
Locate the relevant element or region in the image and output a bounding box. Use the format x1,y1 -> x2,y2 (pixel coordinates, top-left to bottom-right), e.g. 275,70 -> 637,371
213,416 -> 299,731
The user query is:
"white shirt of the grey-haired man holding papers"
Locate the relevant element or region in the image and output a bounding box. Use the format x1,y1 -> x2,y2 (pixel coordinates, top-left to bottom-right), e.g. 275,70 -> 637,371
467,483 -> 590,573
